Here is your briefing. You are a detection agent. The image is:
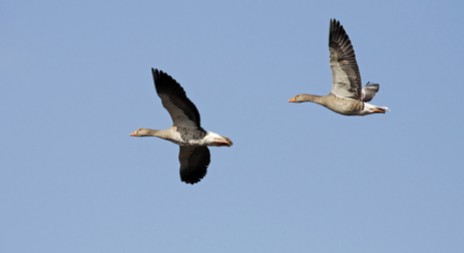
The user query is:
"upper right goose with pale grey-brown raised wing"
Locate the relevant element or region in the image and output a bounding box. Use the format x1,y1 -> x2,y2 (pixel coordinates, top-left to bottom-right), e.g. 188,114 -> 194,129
288,19 -> 389,115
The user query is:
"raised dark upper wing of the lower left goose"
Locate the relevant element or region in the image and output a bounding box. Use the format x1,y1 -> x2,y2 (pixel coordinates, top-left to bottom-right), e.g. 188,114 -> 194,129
151,68 -> 200,128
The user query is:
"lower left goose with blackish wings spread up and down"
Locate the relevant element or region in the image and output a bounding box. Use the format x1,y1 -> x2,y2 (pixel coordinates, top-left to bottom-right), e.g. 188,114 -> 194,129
130,68 -> 232,184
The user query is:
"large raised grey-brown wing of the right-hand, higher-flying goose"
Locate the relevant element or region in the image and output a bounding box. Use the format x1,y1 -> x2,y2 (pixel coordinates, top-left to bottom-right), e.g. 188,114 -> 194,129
329,19 -> 361,100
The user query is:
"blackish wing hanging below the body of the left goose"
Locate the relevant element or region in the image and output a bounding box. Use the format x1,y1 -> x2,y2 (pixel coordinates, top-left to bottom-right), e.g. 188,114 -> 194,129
179,146 -> 211,184
